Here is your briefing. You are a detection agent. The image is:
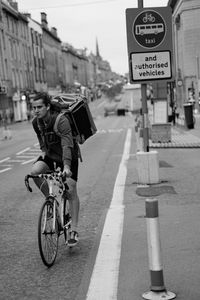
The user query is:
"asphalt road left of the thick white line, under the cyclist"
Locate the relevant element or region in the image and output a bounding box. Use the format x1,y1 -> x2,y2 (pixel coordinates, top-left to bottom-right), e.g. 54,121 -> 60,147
0,99 -> 134,300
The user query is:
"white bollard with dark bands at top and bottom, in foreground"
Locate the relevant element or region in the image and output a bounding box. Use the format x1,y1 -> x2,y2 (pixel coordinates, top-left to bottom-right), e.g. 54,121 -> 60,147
142,199 -> 176,300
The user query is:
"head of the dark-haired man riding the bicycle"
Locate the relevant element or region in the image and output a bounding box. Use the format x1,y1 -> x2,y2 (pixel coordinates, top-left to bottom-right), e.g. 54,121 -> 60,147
32,93 -> 51,119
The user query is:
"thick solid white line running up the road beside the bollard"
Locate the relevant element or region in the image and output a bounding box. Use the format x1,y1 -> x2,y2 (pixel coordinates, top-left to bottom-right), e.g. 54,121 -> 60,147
86,128 -> 131,300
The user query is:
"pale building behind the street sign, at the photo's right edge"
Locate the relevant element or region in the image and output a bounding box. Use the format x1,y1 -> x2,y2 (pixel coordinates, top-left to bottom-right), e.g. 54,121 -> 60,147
168,0 -> 200,110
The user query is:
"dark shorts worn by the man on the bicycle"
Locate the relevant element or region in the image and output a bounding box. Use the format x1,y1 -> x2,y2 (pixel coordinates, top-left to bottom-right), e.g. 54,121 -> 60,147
37,155 -> 78,181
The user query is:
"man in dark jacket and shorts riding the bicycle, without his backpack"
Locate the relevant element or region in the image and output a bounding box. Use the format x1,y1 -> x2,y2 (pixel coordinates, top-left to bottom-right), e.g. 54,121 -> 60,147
31,93 -> 79,247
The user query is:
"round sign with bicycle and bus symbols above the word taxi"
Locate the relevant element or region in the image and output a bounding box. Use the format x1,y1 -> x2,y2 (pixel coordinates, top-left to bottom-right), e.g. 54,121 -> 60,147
132,10 -> 166,49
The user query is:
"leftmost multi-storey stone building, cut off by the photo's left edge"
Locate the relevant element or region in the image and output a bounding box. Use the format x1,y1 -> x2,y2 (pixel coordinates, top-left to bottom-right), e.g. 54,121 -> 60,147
0,0 -> 33,121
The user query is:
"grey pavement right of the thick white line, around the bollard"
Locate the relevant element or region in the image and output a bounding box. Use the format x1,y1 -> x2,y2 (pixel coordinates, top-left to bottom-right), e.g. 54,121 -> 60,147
117,115 -> 200,300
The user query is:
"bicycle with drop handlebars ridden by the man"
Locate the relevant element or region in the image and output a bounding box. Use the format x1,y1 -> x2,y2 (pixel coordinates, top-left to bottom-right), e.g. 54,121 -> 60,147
25,171 -> 71,267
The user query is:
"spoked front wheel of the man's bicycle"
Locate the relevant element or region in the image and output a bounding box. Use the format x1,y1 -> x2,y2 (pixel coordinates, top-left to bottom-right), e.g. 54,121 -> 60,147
38,200 -> 59,267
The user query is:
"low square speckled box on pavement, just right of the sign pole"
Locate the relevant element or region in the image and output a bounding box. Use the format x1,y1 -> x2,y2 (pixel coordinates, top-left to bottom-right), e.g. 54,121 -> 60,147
151,123 -> 172,143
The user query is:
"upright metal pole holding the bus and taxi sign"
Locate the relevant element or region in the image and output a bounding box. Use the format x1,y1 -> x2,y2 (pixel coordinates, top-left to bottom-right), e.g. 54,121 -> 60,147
138,0 -> 149,152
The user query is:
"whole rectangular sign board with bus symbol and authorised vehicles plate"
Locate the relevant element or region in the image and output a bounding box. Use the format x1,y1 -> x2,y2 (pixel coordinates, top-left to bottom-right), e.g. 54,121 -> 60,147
126,7 -> 172,83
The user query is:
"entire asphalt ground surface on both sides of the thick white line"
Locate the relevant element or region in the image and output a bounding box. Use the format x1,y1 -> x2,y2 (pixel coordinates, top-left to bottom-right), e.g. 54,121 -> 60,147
0,99 -> 200,300
